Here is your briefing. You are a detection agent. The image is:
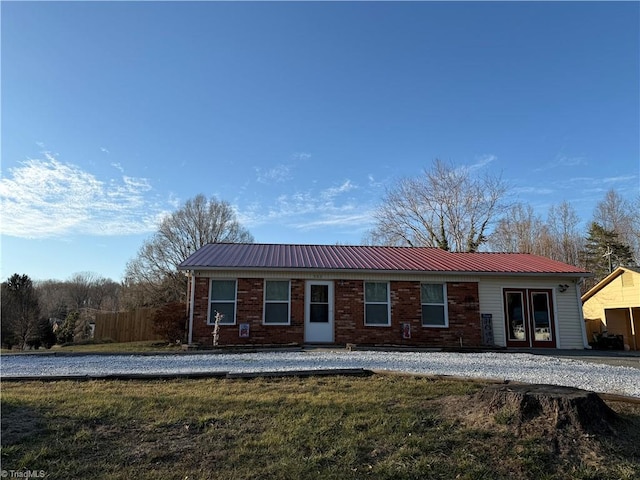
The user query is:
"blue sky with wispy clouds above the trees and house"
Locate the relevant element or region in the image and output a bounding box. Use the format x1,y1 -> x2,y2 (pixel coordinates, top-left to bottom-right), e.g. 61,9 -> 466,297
0,1 -> 640,280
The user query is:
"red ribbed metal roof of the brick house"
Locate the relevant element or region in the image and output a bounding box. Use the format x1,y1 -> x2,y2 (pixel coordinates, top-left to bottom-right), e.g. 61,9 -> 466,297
179,243 -> 589,276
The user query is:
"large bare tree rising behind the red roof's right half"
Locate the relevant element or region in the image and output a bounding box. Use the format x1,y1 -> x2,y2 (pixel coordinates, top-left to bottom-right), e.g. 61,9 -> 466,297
367,160 -> 507,252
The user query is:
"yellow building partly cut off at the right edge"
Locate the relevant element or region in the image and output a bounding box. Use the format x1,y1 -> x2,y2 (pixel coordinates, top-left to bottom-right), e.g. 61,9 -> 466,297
582,267 -> 640,350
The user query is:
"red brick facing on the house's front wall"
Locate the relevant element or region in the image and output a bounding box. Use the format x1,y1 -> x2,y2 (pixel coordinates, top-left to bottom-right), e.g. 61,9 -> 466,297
193,277 -> 482,347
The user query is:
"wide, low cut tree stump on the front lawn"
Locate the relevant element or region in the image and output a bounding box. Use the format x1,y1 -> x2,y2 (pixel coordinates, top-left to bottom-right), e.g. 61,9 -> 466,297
476,384 -> 618,435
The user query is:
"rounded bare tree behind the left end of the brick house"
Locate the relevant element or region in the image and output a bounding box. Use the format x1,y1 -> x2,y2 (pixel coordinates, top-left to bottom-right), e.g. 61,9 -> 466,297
125,194 -> 253,306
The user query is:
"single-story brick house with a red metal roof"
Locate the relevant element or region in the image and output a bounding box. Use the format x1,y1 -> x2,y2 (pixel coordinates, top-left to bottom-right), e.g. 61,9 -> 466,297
179,243 -> 589,349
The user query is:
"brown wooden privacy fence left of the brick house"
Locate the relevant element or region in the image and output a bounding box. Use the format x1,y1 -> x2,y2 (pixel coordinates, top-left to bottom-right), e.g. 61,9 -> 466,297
93,308 -> 162,342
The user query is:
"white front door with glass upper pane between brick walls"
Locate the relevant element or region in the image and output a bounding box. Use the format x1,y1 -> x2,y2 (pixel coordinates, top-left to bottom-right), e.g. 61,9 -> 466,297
304,280 -> 333,343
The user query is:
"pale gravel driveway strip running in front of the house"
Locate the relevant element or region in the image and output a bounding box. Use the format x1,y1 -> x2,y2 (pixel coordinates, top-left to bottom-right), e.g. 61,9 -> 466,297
0,350 -> 640,397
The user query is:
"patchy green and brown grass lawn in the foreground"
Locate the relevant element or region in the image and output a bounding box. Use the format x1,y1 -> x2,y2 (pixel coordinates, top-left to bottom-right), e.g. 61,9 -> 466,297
1,375 -> 640,480
